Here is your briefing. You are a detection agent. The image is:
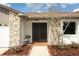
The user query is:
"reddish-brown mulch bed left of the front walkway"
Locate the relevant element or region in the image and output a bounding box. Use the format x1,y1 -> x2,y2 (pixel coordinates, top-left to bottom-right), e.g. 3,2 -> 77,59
2,45 -> 31,56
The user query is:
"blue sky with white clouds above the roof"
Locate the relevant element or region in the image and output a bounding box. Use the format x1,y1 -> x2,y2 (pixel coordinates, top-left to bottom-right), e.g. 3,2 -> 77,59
0,3 -> 79,13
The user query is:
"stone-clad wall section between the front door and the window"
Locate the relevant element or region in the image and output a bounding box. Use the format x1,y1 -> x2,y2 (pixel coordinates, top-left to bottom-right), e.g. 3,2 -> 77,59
49,18 -> 62,45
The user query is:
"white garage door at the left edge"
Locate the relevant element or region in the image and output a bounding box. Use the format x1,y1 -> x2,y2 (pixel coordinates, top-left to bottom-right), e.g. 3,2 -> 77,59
0,26 -> 9,47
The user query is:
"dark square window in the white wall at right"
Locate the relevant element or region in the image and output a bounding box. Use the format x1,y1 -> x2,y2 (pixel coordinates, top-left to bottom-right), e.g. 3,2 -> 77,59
63,22 -> 76,34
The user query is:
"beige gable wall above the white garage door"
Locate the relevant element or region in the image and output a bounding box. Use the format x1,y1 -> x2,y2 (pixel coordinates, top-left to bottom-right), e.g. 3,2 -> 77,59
0,7 -> 9,25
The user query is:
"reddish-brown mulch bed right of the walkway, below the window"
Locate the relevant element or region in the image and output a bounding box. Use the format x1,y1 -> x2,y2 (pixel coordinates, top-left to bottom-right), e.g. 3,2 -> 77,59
48,46 -> 79,56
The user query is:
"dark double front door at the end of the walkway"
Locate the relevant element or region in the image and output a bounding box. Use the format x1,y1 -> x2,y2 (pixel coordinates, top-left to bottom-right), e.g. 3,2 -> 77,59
32,23 -> 47,42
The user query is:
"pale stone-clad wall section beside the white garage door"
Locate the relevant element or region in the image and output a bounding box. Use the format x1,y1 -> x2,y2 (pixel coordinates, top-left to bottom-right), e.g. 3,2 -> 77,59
9,11 -> 20,47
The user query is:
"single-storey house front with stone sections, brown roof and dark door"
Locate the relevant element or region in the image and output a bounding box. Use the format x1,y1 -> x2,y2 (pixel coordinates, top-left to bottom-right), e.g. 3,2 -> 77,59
0,5 -> 79,47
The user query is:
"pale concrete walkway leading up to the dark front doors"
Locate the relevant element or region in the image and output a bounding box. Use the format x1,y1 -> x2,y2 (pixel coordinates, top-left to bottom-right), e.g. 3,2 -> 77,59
30,46 -> 49,56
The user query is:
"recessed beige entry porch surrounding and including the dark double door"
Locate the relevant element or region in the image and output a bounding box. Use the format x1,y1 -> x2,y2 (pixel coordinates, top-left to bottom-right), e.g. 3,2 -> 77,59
21,15 -> 49,43
